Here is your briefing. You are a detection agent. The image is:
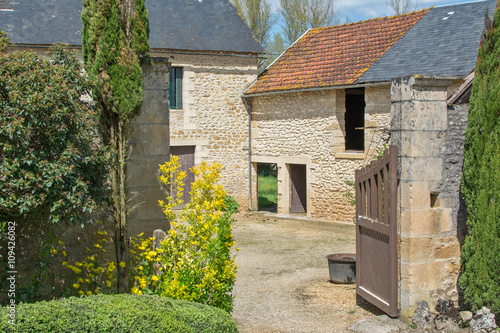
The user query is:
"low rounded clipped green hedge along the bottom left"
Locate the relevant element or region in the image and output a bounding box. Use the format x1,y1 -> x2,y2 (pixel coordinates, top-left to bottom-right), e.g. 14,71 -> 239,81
0,294 -> 238,333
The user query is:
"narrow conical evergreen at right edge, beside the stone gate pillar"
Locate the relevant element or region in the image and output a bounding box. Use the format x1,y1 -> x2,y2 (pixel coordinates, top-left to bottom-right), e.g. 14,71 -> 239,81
459,9 -> 500,314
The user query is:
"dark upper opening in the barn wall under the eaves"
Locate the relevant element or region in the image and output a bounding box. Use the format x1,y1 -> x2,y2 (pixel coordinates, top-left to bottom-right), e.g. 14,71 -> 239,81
345,88 -> 365,151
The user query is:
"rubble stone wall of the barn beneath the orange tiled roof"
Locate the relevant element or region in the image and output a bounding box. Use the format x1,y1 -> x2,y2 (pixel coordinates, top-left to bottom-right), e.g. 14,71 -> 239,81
249,86 -> 390,222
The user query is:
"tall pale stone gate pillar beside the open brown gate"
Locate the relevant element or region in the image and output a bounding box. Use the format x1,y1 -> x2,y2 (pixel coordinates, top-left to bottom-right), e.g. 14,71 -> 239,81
391,75 -> 460,322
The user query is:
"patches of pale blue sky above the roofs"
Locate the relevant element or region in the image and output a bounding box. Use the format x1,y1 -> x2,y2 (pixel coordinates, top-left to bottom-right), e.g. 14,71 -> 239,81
272,0 -> 488,22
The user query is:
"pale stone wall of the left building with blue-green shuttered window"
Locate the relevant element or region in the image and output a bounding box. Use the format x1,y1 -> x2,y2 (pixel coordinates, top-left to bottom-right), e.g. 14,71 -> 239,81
158,54 -> 258,210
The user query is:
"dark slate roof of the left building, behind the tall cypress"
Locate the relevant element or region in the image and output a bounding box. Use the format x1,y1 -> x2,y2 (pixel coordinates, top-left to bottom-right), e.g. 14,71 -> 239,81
0,0 -> 264,53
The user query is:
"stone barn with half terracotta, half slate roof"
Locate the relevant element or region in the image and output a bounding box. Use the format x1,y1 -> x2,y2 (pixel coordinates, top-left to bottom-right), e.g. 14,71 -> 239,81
244,1 -> 491,222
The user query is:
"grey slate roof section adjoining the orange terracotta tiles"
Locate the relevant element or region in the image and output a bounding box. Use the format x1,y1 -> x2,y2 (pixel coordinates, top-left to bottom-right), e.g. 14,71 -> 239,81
356,1 -> 494,83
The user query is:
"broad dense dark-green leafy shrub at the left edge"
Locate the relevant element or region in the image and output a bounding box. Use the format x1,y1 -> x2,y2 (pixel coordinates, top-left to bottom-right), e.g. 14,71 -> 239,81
0,31 -> 109,225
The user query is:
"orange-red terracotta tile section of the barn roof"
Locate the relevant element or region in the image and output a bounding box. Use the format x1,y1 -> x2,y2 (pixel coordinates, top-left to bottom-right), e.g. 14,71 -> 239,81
245,9 -> 429,95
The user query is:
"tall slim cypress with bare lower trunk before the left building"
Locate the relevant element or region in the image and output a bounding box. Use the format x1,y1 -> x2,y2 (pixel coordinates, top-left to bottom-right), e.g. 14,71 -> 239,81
82,0 -> 149,293
